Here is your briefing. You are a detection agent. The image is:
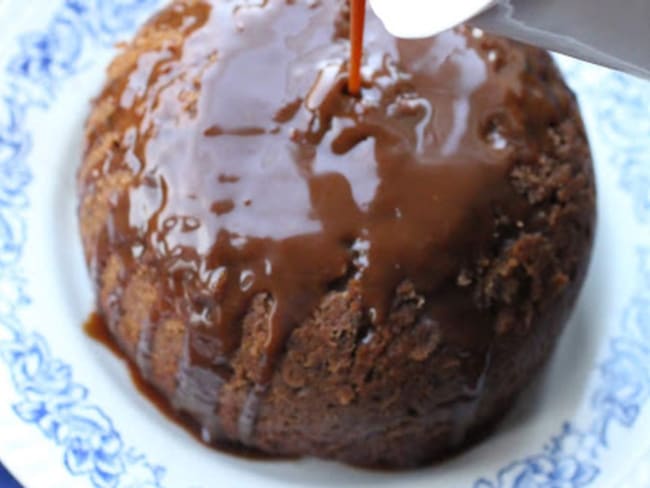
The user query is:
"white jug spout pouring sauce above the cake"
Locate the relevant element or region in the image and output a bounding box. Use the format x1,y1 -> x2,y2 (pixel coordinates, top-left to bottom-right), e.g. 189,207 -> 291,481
370,0 -> 650,79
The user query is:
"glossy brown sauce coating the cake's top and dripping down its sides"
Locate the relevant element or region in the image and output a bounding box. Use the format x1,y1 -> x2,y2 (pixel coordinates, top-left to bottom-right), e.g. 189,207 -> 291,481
81,0 -> 554,443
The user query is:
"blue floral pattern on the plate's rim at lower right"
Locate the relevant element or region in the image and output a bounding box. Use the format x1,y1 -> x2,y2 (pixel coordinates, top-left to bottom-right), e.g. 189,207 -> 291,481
474,248 -> 650,488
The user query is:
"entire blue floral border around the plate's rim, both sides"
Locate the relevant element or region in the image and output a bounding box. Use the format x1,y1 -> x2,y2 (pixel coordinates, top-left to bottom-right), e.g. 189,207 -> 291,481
0,0 -> 650,488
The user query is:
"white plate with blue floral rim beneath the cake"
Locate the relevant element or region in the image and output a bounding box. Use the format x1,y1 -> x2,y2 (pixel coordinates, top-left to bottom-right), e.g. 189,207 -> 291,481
0,0 -> 650,488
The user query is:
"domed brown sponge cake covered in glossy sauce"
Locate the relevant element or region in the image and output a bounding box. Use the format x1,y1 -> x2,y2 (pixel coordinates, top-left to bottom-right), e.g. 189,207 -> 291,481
78,0 -> 595,467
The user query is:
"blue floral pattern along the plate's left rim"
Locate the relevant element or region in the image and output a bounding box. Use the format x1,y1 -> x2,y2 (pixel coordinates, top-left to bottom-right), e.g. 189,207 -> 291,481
0,0 -> 165,488
